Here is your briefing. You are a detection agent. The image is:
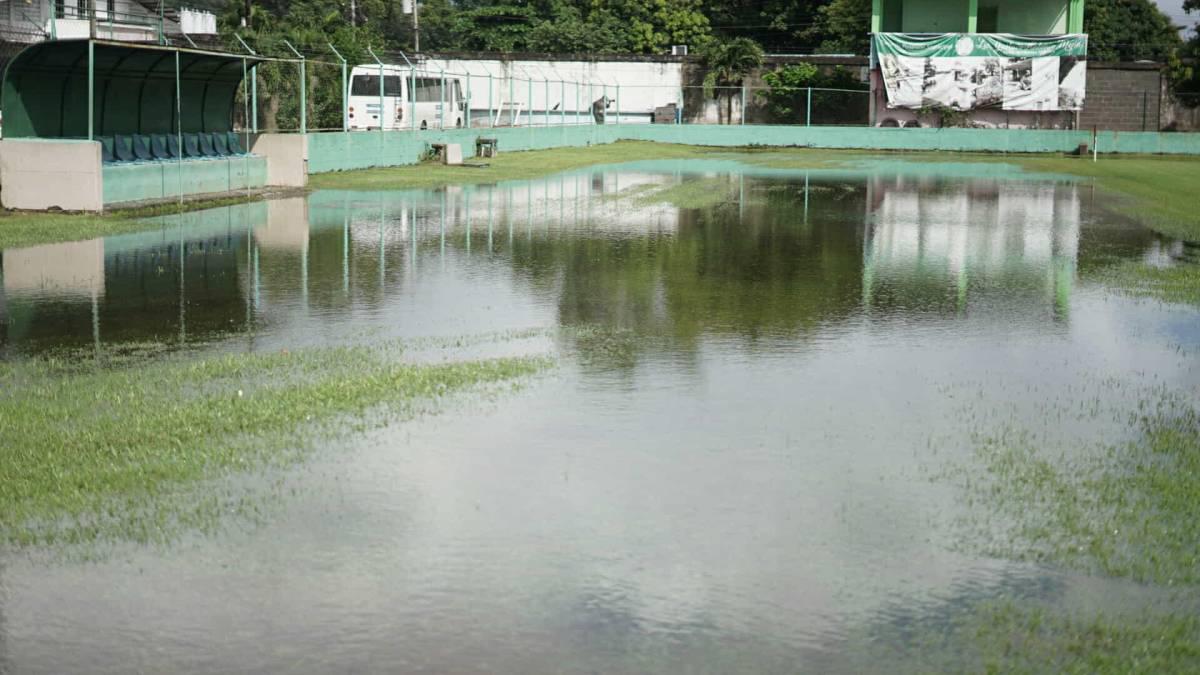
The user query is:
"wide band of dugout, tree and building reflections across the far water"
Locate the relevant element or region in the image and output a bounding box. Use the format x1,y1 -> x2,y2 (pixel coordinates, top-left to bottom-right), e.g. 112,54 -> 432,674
0,167 -> 1159,353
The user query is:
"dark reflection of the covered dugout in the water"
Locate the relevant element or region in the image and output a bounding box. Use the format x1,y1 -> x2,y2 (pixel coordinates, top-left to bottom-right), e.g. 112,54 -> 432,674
0,204 -> 265,351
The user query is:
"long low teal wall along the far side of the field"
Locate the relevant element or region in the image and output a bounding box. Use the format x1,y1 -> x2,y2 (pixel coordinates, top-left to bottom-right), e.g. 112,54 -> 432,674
300,125 -> 1200,180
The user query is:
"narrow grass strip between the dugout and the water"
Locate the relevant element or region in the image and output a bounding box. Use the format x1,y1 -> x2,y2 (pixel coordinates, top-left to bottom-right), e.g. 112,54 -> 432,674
0,195 -> 265,249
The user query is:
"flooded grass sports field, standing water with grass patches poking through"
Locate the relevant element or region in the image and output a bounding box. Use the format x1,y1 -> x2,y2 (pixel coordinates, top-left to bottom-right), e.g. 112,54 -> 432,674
0,159 -> 1200,673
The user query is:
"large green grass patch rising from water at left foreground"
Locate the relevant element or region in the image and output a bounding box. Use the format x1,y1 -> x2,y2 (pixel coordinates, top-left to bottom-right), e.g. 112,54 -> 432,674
0,347 -> 550,545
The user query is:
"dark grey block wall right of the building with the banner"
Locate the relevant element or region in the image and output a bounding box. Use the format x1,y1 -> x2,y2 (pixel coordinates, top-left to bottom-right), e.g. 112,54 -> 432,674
1079,62 -> 1165,131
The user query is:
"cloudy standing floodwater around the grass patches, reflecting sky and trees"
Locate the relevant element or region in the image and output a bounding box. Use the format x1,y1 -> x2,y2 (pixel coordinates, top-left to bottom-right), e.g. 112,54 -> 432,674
0,161 -> 1200,674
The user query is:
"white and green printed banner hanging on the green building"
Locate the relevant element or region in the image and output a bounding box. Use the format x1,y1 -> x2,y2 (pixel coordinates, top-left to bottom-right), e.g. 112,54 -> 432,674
874,32 -> 1087,110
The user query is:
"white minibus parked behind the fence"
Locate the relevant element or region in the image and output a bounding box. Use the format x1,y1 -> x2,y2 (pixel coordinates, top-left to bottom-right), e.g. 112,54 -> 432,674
347,65 -> 467,130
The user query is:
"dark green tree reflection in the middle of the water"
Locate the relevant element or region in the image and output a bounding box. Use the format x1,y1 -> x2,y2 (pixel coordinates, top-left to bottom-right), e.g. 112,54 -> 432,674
501,177 -> 864,366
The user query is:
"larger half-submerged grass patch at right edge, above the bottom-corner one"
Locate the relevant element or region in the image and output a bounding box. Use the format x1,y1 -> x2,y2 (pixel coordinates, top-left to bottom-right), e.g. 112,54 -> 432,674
954,392 -> 1200,586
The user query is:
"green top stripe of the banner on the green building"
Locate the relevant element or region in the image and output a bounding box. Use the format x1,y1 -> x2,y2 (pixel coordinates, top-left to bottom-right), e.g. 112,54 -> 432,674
875,32 -> 1087,59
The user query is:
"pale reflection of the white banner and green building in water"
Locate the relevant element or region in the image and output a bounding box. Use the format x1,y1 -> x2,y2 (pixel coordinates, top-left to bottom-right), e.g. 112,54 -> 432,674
863,177 -> 1080,316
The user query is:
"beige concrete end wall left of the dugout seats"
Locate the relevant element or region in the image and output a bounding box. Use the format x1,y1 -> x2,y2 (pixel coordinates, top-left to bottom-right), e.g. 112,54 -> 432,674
0,139 -> 104,211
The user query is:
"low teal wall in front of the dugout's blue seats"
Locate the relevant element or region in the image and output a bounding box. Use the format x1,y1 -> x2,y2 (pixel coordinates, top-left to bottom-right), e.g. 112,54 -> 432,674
101,156 -> 266,204
